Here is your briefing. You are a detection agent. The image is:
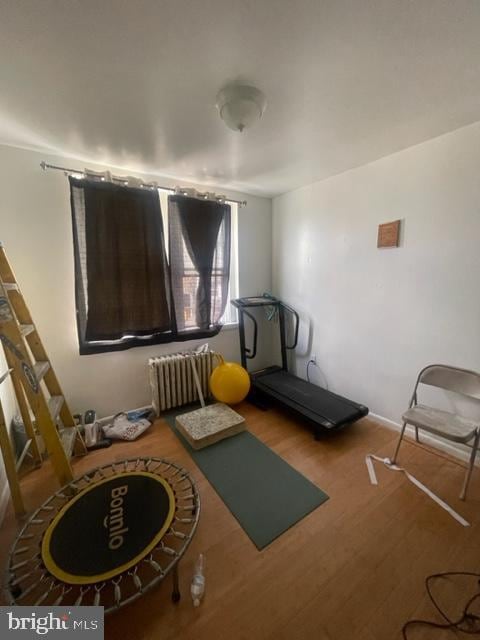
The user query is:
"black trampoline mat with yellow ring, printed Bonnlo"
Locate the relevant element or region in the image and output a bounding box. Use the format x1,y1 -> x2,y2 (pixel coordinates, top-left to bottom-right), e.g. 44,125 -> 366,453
42,471 -> 175,584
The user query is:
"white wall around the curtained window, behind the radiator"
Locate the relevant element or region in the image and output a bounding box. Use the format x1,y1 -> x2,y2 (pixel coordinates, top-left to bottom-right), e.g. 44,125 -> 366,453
0,146 -> 272,415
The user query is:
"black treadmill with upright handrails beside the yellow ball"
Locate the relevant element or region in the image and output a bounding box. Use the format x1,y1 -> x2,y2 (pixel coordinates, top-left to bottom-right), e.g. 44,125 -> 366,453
231,295 -> 368,438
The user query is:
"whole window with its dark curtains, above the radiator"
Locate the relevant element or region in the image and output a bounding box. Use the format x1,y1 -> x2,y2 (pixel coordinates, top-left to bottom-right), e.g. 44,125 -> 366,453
70,177 -> 238,354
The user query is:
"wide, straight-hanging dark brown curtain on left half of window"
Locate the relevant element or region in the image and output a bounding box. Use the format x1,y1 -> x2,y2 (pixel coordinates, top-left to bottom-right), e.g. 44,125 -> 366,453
70,177 -> 173,353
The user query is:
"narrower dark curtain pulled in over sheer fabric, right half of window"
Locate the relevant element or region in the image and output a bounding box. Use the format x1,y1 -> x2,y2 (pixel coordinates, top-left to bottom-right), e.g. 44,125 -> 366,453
168,195 -> 231,337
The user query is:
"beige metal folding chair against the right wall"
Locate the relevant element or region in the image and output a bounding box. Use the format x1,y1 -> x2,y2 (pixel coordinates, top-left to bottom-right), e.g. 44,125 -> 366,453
392,364 -> 480,500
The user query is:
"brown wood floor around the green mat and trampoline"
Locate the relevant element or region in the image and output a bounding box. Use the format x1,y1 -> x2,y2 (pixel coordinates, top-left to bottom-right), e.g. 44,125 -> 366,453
0,404 -> 480,640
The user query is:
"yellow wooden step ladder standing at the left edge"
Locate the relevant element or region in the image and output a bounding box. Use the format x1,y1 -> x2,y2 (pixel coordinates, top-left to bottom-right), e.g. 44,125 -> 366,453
0,243 -> 87,498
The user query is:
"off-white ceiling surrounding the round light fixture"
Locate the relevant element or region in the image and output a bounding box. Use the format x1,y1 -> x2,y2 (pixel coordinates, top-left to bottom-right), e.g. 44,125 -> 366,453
0,0 -> 480,196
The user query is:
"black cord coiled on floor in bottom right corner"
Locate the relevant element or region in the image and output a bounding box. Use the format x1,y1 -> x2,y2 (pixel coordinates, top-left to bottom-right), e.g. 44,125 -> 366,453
402,571 -> 480,640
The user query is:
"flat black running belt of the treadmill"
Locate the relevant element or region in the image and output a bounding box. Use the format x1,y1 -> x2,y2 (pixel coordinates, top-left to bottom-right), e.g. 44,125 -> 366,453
253,371 -> 368,427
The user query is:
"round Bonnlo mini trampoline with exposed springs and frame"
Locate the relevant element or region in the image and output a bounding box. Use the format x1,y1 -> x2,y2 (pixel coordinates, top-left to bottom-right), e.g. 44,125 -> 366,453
6,458 -> 200,613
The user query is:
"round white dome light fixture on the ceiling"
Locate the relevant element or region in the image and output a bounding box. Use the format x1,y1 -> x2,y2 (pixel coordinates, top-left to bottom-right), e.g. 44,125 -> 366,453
217,84 -> 267,132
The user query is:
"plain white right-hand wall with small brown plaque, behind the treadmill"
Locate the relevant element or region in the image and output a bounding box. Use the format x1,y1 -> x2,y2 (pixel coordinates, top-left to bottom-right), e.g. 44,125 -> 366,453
273,123 -> 480,422
